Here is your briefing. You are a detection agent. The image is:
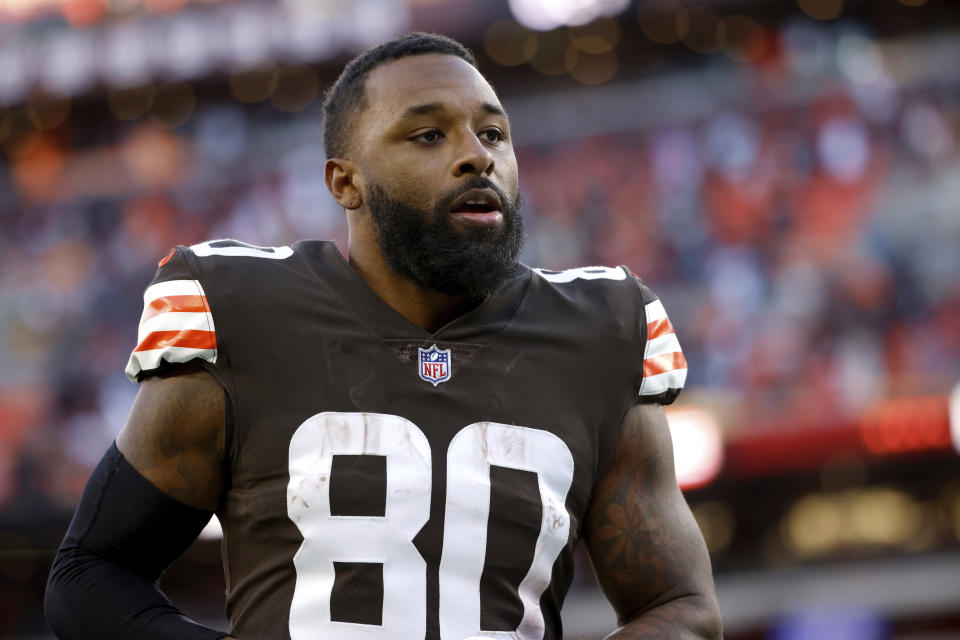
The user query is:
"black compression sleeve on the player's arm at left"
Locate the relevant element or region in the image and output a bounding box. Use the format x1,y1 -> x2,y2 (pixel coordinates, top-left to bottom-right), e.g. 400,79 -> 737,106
44,444 -> 228,640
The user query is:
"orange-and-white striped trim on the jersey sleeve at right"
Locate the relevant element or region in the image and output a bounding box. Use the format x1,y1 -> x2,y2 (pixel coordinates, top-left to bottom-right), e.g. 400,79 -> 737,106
640,300 -> 687,396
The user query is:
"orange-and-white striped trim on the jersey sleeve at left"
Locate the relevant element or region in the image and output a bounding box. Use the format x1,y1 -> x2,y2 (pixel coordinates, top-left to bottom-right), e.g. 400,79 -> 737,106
125,280 -> 217,381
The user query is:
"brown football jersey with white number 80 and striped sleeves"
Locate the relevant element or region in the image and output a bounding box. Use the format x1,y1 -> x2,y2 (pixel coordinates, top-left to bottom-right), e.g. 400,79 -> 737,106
127,240 -> 686,640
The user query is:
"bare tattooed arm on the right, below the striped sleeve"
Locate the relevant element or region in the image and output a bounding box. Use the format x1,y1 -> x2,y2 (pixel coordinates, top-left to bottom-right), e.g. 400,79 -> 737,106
584,405 -> 723,640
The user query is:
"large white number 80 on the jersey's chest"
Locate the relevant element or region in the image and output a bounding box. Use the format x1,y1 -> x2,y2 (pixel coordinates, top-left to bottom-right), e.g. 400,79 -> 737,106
287,412 -> 573,640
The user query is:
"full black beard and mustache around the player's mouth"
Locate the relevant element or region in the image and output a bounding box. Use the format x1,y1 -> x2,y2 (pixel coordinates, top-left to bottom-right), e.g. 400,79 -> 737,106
367,178 -> 523,301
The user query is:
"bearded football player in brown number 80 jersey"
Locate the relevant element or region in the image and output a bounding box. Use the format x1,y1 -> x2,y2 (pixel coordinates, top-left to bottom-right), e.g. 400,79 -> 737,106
46,34 -> 720,640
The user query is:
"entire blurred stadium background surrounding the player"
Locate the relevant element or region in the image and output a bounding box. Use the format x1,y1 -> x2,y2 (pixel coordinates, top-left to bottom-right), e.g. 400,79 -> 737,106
0,0 -> 960,640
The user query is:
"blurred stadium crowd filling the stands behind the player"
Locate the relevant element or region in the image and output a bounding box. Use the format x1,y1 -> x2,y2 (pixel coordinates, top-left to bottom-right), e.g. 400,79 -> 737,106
0,0 -> 960,631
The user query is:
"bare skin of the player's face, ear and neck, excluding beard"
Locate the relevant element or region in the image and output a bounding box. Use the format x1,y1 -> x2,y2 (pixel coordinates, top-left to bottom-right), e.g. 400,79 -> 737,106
324,55 -> 518,330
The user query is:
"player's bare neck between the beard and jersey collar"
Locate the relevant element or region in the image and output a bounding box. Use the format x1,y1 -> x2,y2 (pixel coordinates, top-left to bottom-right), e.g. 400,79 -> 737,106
347,230 -> 471,332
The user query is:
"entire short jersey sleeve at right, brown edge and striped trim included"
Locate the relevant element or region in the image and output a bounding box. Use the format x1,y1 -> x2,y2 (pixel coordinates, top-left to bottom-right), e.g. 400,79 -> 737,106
635,278 -> 687,404
